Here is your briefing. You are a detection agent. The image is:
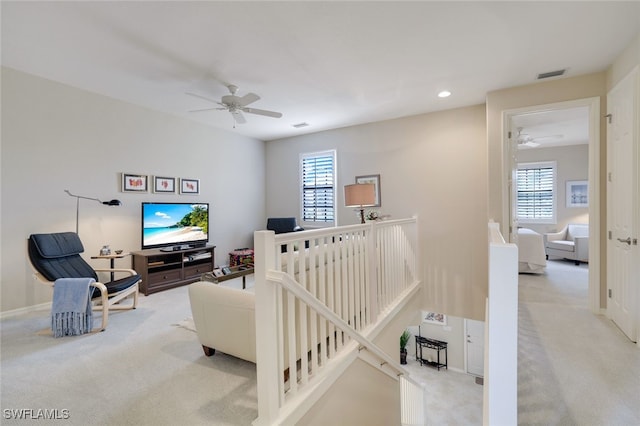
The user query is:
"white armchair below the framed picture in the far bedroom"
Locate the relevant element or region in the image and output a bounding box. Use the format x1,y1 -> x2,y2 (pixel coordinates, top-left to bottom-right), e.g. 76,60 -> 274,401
543,223 -> 589,265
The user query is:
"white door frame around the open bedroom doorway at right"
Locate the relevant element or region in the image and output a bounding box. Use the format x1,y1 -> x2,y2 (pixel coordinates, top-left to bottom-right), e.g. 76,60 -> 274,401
502,97 -> 604,314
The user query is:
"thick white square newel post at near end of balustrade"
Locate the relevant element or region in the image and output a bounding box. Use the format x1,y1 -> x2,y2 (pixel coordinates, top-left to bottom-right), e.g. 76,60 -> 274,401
253,231 -> 281,426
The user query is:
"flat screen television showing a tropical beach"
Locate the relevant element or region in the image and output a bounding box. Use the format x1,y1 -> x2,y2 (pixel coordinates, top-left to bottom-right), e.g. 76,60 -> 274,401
142,202 -> 209,250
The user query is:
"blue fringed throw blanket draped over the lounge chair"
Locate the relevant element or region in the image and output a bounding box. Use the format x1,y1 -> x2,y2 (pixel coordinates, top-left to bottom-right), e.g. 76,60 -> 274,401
51,278 -> 95,337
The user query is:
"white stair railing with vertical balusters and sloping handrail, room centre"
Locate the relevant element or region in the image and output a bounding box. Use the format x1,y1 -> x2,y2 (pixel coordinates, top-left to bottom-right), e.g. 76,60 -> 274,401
254,219 -> 419,425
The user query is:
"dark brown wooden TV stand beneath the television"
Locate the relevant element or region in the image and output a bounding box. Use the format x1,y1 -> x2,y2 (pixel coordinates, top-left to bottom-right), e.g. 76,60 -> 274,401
131,246 -> 216,296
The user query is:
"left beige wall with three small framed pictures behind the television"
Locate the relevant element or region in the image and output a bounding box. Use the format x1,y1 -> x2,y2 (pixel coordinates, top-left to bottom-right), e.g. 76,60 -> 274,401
0,68 -> 265,312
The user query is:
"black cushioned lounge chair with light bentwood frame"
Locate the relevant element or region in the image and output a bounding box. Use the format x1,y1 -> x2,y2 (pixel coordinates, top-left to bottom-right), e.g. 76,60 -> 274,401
28,232 -> 142,331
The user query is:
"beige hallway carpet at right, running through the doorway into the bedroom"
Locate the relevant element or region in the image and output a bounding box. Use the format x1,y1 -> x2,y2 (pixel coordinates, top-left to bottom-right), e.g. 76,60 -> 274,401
518,261 -> 640,426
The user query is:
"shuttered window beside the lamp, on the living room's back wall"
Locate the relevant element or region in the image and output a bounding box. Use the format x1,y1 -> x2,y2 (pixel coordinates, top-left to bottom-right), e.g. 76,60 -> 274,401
300,150 -> 336,224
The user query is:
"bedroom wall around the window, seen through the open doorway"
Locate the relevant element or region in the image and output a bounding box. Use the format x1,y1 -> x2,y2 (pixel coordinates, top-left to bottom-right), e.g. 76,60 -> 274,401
518,145 -> 589,234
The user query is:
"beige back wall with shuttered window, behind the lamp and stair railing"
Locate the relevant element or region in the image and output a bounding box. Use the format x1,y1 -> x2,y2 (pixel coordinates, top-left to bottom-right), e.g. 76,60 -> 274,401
266,105 -> 487,322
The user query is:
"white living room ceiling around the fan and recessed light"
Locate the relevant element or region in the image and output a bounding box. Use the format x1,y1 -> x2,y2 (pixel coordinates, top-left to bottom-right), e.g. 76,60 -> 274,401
1,1 -> 640,140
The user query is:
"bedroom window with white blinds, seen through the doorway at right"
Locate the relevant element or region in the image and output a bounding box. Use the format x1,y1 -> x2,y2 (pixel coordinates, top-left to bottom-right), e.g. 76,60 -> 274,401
516,161 -> 556,223
